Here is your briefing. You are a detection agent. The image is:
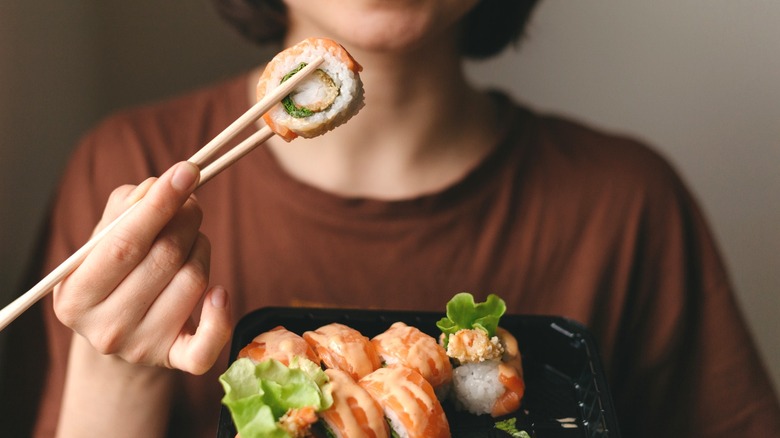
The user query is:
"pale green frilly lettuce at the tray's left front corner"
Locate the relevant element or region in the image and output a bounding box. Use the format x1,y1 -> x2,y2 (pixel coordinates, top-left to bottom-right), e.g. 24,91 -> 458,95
219,357 -> 333,438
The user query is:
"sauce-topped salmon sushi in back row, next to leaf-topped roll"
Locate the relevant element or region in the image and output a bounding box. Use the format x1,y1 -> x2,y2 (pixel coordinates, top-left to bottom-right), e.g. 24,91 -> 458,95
371,321 -> 452,399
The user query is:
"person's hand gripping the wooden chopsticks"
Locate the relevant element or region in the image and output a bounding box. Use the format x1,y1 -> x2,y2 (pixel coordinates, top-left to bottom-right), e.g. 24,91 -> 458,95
54,162 -> 232,374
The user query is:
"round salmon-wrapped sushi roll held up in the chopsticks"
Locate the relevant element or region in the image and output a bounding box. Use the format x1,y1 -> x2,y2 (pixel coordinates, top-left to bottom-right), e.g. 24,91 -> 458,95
257,38 -> 364,141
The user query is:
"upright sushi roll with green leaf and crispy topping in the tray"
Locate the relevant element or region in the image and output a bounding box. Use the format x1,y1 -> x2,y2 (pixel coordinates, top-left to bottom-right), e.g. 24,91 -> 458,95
436,293 -> 525,417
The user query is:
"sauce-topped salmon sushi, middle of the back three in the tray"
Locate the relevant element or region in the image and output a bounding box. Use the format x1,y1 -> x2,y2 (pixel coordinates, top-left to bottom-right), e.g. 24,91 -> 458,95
303,323 -> 382,380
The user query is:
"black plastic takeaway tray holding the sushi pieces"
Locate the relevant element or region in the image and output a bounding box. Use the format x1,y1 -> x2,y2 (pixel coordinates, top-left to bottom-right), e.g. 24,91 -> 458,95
217,307 -> 620,438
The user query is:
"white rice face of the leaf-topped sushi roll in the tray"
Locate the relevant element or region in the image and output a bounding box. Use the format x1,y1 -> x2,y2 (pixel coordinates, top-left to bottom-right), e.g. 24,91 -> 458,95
452,360 -> 504,415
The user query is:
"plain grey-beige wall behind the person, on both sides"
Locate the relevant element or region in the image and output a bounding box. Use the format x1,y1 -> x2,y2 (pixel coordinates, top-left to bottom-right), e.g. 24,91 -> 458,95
0,0 -> 780,396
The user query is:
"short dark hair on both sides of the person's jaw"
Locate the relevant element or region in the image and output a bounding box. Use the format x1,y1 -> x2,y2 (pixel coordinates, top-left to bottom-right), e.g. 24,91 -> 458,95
213,0 -> 538,59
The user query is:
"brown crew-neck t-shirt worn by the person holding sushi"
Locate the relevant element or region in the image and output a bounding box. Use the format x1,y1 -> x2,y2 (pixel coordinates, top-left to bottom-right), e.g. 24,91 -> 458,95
13,72 -> 780,438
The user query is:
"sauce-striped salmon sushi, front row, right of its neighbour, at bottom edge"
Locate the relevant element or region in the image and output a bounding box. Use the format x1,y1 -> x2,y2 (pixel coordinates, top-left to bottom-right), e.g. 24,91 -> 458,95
358,366 -> 450,438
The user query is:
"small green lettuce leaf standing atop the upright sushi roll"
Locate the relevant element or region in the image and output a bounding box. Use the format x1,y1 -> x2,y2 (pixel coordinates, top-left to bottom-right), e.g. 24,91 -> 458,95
436,292 -> 506,346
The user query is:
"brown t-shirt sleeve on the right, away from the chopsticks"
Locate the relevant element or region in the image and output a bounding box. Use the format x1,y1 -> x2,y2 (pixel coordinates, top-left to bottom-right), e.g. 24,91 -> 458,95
610,150 -> 780,437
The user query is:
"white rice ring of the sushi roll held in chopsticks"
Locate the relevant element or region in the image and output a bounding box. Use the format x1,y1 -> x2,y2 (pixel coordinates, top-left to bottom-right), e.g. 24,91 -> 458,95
258,41 -> 364,138
